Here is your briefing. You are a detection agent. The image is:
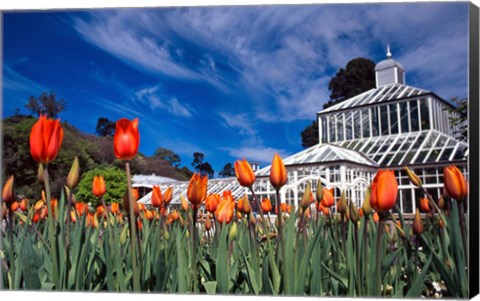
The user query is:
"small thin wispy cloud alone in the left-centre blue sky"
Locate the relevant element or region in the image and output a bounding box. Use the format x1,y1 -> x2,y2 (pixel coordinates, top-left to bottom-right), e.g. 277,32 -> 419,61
134,85 -> 195,118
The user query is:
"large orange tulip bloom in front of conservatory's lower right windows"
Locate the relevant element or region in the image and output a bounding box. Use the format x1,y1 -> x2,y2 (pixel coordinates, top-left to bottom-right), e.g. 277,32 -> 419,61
370,170 -> 398,213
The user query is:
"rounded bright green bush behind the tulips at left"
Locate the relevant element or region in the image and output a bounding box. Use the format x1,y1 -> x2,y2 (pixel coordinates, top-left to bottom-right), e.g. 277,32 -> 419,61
75,167 -> 127,205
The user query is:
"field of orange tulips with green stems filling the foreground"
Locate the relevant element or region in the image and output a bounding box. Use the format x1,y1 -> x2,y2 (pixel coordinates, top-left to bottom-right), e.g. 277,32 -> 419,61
0,116 -> 469,298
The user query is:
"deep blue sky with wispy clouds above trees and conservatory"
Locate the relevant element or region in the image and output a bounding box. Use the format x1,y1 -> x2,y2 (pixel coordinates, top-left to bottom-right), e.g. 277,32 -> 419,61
2,2 -> 468,172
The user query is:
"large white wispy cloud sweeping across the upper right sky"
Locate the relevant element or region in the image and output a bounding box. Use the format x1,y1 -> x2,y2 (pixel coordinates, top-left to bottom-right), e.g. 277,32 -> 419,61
75,3 -> 467,123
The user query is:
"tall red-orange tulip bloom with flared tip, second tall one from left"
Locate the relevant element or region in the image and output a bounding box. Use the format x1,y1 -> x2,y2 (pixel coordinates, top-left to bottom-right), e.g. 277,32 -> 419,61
113,118 -> 140,160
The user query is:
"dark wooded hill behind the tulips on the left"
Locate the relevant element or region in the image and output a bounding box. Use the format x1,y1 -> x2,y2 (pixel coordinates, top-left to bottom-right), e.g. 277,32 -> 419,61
2,115 -> 192,198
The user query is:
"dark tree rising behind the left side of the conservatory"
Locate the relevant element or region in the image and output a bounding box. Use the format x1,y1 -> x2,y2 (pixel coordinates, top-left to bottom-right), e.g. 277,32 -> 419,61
301,57 -> 375,148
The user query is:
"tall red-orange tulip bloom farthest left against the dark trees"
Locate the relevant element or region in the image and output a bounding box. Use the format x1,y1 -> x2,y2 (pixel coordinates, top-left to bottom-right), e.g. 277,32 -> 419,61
30,115 -> 63,163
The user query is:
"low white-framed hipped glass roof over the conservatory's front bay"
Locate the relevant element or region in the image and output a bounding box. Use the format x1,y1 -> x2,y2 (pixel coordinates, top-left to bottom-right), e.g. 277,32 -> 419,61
255,143 -> 377,177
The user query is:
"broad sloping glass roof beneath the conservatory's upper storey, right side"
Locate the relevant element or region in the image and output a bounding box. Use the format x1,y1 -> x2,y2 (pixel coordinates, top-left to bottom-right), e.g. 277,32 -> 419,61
334,130 -> 468,166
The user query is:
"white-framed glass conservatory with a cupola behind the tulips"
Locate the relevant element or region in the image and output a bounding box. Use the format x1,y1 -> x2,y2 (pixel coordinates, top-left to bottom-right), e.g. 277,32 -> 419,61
137,51 -> 468,214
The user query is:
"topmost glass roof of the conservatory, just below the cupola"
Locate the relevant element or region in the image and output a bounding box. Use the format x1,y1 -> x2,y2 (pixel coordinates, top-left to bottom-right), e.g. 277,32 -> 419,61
318,84 -> 431,114
